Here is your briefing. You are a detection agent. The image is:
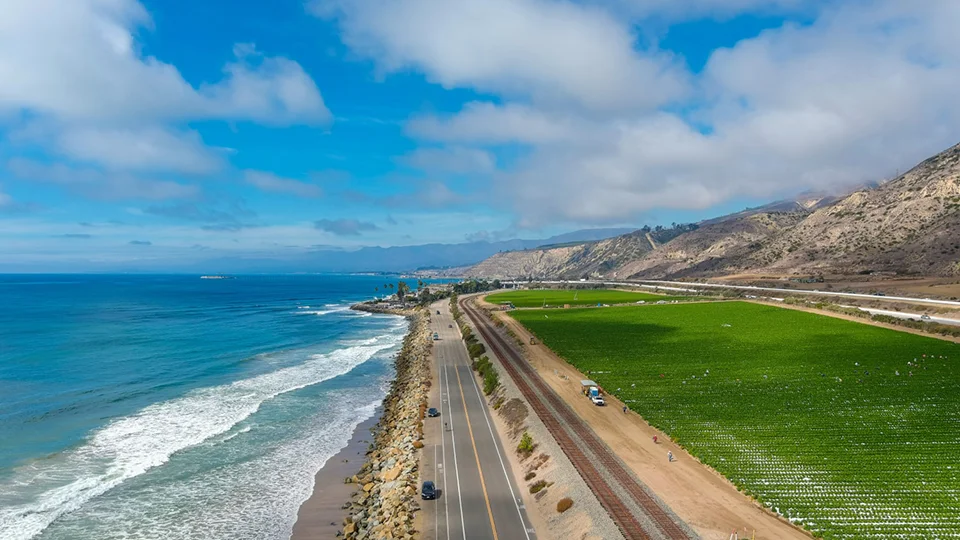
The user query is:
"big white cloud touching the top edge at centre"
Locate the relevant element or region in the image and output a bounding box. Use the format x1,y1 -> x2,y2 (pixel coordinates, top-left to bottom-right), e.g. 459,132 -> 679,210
312,0 -> 686,111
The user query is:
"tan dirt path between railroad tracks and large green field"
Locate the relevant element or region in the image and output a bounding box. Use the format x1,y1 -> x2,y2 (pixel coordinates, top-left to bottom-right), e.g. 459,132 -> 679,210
476,298 -> 812,540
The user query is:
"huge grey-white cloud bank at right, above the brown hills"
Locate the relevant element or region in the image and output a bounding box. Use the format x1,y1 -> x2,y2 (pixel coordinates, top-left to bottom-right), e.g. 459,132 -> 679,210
388,0 -> 960,227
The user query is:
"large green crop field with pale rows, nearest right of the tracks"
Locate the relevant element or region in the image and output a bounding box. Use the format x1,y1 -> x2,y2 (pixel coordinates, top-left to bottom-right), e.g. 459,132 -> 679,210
510,302 -> 960,539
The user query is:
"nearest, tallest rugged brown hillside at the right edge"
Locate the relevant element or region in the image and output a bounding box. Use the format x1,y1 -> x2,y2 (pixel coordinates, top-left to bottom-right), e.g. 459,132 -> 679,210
735,145 -> 960,275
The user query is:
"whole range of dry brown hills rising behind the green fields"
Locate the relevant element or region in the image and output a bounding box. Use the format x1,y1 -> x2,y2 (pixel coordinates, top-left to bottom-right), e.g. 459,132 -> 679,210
467,141 -> 960,279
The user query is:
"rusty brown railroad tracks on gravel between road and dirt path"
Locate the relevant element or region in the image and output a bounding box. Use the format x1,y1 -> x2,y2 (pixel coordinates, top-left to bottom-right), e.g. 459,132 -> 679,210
460,300 -> 692,540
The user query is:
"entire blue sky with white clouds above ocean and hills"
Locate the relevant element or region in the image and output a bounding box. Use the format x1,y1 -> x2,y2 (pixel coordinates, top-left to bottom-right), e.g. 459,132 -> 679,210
0,0 -> 960,270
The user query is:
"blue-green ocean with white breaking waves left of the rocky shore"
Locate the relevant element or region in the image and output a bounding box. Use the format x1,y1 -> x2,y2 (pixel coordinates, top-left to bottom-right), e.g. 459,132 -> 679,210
0,275 -> 406,540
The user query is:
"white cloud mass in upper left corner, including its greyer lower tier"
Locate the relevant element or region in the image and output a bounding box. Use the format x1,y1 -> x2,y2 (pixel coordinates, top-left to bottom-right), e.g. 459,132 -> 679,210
0,0 -> 332,198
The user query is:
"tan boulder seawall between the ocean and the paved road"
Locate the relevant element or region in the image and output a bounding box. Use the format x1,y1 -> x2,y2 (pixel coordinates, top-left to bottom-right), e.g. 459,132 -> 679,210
343,304 -> 433,540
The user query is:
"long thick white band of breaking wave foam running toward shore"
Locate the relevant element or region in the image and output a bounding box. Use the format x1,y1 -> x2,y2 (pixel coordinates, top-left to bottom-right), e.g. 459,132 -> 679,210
0,334 -> 402,540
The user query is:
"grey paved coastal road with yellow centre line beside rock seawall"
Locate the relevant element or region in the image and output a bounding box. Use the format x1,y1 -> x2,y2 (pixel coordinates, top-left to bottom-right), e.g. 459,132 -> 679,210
420,301 -> 536,540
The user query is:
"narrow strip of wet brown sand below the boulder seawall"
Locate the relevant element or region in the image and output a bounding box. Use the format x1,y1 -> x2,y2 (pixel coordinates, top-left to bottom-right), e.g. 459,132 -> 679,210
291,408 -> 382,540
